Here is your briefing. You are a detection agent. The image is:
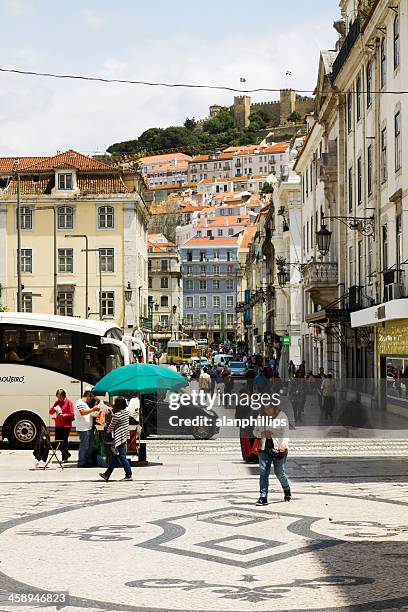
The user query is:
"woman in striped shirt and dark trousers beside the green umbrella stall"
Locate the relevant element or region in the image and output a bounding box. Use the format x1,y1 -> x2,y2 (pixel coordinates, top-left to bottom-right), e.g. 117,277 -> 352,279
99,397 -> 133,482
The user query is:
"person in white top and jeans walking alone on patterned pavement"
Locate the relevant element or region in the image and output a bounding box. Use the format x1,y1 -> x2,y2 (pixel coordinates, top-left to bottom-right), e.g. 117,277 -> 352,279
254,404 -> 292,506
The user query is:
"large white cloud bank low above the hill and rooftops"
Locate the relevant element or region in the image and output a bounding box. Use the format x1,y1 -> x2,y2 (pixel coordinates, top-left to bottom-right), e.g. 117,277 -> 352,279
0,16 -> 335,155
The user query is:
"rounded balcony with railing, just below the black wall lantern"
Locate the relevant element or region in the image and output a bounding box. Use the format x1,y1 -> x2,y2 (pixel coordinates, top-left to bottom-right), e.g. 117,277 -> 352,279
303,261 -> 338,306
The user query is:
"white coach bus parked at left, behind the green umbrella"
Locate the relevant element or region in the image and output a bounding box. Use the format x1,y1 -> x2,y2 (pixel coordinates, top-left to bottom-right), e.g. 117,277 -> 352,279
0,312 -> 131,448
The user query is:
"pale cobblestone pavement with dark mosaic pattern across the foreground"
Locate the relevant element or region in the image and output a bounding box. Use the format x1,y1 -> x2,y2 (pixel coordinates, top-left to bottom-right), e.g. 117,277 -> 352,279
0,449 -> 408,612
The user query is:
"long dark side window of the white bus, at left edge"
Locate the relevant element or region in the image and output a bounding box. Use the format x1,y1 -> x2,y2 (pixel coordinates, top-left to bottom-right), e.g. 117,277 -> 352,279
0,326 -> 72,375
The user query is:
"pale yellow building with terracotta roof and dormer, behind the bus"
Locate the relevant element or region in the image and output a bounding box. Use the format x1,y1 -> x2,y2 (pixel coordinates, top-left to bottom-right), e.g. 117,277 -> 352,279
0,150 -> 149,331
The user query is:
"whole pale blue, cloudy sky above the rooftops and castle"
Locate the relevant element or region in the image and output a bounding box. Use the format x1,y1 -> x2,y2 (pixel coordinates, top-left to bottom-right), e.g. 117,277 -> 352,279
0,0 -> 339,156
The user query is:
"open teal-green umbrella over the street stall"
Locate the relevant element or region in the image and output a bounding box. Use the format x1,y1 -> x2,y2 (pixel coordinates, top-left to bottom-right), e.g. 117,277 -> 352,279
92,363 -> 188,395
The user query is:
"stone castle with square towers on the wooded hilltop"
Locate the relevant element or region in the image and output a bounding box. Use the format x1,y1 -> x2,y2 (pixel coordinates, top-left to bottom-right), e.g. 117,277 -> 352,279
210,89 -> 314,129
